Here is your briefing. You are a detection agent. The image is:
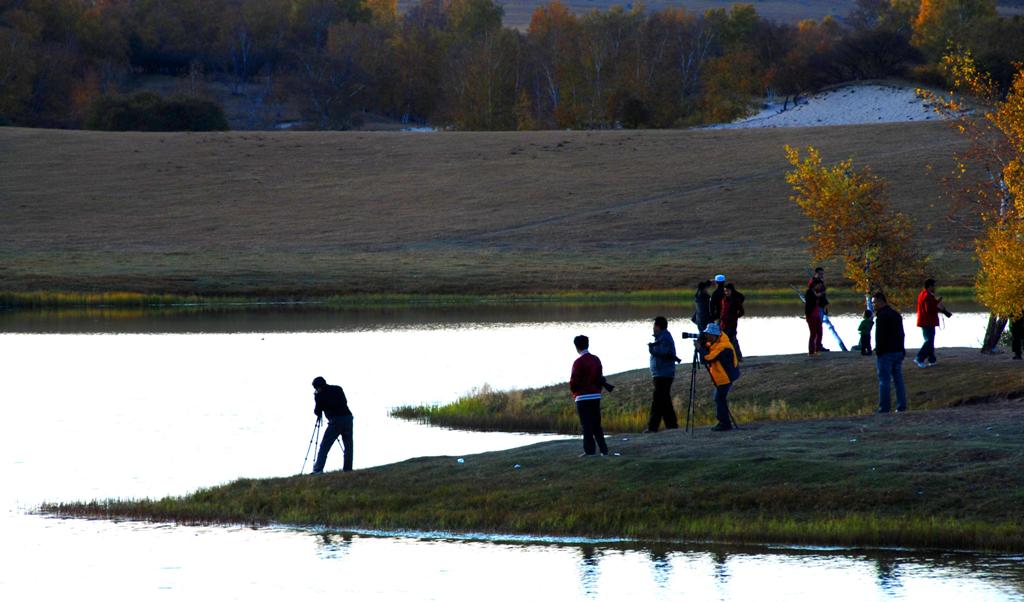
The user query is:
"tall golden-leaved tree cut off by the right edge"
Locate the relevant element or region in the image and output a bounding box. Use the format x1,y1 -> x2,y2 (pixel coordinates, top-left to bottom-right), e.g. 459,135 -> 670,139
919,51 -> 1024,352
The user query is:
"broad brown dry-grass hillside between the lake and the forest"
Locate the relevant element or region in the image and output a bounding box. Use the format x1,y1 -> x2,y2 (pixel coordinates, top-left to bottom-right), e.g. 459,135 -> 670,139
0,123 -> 972,295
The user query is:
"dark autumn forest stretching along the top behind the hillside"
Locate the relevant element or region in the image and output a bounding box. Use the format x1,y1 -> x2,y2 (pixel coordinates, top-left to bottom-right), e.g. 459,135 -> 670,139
6,0 -> 1024,130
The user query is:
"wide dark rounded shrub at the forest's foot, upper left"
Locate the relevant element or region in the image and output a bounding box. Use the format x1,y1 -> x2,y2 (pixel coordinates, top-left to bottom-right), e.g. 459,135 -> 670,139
85,92 -> 228,132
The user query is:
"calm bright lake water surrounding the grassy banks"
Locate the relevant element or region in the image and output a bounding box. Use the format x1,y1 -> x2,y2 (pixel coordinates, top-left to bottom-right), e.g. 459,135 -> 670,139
0,306 -> 1024,601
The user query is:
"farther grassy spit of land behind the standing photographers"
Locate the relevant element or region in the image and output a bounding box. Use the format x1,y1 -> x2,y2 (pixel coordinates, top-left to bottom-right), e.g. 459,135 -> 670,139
392,347 -> 1024,434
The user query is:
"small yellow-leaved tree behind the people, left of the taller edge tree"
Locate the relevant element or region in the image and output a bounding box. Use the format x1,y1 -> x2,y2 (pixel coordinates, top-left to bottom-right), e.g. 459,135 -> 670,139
785,146 -> 927,306
